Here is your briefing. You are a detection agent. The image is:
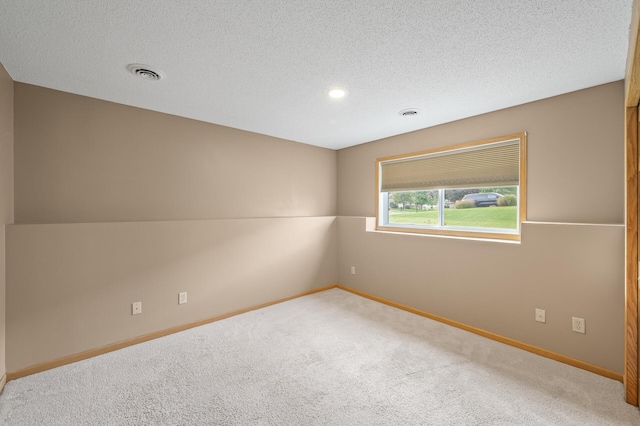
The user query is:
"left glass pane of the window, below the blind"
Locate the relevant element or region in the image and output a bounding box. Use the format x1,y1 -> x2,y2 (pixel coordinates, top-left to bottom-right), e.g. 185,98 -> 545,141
388,190 -> 439,226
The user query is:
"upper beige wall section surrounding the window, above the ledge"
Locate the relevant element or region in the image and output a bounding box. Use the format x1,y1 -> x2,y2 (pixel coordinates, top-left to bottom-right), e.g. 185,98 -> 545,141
338,81 -> 624,224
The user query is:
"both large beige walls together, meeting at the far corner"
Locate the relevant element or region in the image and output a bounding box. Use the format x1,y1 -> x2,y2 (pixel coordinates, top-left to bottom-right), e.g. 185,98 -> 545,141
6,77 -> 624,372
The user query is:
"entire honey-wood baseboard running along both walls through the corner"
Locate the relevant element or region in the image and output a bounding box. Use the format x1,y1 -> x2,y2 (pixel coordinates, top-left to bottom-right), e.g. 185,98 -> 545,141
5,284 -> 623,382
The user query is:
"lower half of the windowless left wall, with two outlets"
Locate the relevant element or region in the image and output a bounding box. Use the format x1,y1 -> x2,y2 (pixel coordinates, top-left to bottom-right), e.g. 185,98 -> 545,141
7,217 -> 337,371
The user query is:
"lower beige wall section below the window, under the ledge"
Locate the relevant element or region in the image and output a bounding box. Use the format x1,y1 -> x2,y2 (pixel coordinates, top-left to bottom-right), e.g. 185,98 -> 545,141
338,217 -> 624,373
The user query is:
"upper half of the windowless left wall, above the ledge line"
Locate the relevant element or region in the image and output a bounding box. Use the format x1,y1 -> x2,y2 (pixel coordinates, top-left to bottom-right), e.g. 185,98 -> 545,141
15,83 -> 337,223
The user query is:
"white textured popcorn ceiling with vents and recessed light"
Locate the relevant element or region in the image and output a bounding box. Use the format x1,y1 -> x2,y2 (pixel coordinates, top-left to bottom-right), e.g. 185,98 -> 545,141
0,0 -> 632,149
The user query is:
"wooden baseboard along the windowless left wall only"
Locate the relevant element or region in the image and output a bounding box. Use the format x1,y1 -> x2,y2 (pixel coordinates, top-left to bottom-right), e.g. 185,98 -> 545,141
6,284 -> 337,381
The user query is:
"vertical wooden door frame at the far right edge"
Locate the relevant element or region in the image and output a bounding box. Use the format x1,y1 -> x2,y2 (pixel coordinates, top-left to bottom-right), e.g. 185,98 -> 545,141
624,0 -> 640,406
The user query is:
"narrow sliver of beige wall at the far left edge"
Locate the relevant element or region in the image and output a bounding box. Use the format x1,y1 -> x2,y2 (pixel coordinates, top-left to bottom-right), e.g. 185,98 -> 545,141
0,64 -> 13,379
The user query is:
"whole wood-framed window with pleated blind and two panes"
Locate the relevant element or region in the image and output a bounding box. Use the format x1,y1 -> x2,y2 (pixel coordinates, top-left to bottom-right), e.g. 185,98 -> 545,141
376,133 -> 527,240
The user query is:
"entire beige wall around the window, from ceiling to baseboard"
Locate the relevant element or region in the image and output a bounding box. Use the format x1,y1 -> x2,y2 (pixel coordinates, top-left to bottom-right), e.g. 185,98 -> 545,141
338,82 -> 624,372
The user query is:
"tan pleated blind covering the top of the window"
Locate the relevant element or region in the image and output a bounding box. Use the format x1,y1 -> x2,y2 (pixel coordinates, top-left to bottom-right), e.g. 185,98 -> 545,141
380,138 -> 520,192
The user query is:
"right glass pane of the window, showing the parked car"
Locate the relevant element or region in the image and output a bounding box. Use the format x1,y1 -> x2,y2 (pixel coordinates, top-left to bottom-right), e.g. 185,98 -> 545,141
444,186 -> 518,230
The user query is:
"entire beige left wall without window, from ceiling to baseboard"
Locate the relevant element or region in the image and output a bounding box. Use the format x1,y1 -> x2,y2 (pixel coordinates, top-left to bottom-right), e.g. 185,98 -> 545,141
6,83 -> 337,371
